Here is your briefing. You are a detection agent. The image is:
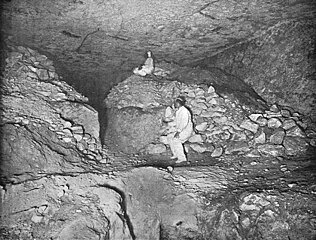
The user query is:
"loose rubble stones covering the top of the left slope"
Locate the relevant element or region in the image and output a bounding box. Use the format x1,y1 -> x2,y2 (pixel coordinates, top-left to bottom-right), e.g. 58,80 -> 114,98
2,46 -> 106,162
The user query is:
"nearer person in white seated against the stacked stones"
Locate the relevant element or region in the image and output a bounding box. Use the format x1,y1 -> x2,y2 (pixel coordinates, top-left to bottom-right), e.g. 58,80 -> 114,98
167,97 -> 193,163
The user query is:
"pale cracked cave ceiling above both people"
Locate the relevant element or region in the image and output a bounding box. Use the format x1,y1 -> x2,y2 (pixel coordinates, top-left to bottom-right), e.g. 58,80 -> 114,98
2,0 -> 315,86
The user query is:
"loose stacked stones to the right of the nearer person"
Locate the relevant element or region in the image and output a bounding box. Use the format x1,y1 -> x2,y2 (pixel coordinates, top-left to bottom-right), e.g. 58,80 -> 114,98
156,84 -> 308,157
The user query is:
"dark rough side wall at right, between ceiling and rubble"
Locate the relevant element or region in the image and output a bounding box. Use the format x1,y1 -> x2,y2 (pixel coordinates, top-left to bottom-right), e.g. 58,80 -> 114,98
196,20 -> 316,121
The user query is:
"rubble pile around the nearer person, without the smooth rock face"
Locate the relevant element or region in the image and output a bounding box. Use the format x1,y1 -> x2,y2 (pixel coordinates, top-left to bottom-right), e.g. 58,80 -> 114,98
105,76 -> 316,157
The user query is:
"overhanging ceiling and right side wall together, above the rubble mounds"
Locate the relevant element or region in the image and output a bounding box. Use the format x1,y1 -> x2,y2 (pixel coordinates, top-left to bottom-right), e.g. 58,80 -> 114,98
2,0 -> 316,119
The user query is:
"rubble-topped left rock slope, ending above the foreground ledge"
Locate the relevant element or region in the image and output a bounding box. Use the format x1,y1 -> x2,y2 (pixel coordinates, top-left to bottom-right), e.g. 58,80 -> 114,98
1,47 -> 100,181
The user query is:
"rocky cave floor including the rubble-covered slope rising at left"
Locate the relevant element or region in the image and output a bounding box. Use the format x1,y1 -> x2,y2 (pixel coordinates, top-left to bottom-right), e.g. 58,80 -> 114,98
0,47 -> 316,240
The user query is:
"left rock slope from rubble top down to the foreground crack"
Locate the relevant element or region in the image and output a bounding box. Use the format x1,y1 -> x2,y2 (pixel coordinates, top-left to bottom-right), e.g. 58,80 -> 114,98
0,46 -> 132,240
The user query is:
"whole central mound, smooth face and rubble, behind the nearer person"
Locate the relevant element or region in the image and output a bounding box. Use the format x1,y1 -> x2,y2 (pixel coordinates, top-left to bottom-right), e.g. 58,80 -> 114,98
105,73 -> 314,156
